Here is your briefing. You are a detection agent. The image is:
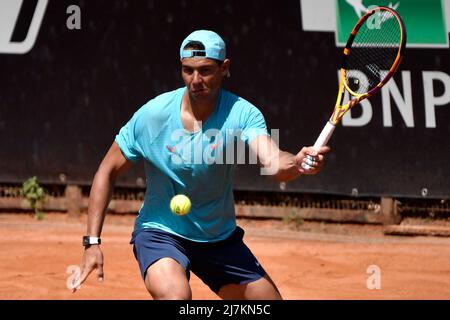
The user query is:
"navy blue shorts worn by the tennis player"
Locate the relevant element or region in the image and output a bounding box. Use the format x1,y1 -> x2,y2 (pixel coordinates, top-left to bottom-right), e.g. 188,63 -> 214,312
130,227 -> 266,293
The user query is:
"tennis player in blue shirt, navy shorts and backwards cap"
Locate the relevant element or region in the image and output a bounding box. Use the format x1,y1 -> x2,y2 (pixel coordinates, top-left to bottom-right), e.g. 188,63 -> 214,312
74,30 -> 329,299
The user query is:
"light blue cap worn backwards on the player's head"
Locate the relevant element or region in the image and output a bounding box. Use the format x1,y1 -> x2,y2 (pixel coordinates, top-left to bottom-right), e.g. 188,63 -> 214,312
180,30 -> 226,61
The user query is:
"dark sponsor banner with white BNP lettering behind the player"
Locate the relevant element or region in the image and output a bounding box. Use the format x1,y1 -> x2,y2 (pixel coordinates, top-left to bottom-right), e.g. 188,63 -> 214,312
0,0 -> 450,198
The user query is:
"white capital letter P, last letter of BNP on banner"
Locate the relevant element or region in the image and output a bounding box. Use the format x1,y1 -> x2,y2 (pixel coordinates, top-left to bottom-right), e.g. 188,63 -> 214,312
423,71 -> 450,128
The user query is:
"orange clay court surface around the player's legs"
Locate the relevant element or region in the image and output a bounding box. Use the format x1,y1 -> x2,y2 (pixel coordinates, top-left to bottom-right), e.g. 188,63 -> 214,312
0,213 -> 450,300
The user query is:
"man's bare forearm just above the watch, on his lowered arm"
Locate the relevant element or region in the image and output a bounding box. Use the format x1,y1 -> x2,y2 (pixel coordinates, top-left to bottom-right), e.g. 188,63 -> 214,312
87,171 -> 114,237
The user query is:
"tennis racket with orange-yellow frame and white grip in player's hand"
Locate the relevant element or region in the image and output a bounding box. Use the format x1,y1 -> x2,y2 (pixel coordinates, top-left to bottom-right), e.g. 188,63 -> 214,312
312,7 -> 406,153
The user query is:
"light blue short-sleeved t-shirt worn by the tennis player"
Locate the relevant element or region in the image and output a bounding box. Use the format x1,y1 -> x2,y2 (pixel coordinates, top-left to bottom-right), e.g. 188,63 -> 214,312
115,87 -> 268,242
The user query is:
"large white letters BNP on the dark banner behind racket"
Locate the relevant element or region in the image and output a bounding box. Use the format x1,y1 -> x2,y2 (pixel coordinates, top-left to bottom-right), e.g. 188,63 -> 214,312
338,70 -> 450,128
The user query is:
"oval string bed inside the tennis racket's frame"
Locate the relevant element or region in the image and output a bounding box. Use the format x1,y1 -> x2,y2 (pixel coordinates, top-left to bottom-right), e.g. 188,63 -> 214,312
346,11 -> 401,94
